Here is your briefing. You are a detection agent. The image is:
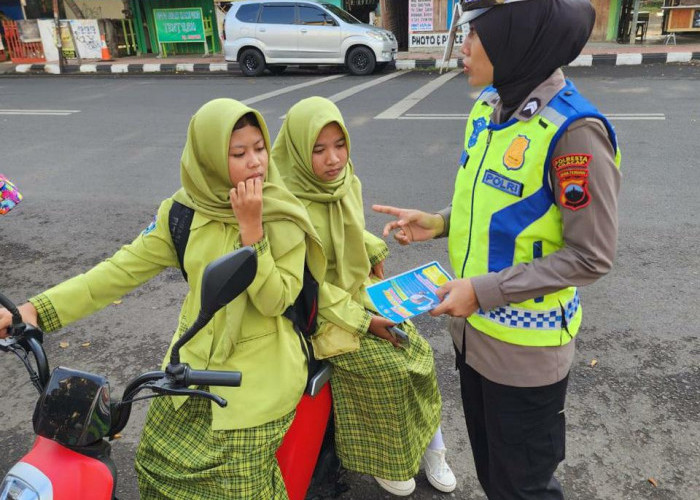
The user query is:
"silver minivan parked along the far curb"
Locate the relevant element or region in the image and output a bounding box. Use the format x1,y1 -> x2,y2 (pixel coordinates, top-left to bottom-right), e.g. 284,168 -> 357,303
223,0 -> 398,76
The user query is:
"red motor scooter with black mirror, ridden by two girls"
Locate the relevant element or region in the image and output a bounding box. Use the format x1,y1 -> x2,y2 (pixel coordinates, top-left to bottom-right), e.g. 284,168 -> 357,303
0,247 -> 339,500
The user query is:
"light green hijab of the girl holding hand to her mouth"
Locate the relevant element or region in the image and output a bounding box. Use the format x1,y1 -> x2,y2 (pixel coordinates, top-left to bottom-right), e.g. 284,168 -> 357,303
173,98 -> 325,283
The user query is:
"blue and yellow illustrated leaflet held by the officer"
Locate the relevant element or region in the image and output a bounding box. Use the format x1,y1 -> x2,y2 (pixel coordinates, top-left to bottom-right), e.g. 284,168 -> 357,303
367,261 -> 452,323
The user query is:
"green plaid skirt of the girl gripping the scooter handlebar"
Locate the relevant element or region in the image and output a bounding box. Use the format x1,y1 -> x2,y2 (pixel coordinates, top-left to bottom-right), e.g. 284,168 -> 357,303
136,397 -> 294,500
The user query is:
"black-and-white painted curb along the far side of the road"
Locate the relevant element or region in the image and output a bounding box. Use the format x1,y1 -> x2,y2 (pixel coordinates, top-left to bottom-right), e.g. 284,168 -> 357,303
5,52 -> 700,75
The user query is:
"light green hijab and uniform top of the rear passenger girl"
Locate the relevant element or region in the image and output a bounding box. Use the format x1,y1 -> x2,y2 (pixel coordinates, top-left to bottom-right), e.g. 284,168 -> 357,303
272,97 -> 388,357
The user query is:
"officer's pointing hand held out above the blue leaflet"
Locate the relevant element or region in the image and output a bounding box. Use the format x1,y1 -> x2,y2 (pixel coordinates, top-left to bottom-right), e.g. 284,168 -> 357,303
372,205 -> 445,245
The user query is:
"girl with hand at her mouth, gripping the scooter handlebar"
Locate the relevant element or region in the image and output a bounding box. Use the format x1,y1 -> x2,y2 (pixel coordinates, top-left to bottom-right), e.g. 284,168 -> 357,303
0,99 -> 325,500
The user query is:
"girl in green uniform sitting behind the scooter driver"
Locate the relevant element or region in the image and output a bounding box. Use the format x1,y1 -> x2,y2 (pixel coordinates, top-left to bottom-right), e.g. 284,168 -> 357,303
272,97 -> 456,495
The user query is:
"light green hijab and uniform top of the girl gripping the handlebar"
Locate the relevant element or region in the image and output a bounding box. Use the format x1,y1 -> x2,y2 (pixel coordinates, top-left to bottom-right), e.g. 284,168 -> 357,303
30,99 -> 325,430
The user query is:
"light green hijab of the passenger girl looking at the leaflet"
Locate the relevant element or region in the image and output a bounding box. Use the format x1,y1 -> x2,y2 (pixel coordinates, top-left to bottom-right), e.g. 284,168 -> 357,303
271,97 -> 370,295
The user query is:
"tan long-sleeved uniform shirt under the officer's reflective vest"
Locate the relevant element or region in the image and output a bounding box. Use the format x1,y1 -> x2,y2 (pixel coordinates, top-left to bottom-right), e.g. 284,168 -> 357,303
439,70 -> 621,387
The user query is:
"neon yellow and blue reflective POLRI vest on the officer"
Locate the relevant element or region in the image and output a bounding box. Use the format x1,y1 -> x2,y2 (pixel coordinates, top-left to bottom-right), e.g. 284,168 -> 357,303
449,81 -> 620,346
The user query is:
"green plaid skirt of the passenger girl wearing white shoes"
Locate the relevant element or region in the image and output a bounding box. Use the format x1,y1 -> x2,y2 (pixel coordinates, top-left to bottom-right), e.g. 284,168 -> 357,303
328,321 -> 442,481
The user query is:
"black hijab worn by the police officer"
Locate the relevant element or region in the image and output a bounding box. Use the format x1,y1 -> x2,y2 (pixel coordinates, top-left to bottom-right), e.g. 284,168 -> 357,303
471,0 -> 595,118
